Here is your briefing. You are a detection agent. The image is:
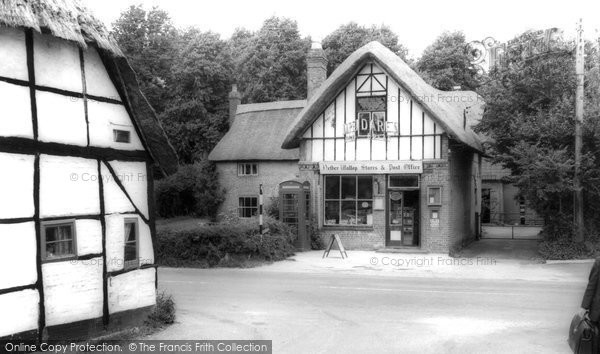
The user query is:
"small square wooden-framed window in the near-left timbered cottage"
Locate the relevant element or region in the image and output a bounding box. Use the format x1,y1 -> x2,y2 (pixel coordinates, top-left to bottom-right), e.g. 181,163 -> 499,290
42,220 -> 77,261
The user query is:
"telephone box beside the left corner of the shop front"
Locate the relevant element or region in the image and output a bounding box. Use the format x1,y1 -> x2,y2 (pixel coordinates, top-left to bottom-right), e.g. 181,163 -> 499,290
279,181 -> 310,250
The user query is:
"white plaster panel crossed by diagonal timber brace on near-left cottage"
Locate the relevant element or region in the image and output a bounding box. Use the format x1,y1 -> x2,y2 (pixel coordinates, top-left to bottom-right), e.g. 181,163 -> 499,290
102,161 -> 149,218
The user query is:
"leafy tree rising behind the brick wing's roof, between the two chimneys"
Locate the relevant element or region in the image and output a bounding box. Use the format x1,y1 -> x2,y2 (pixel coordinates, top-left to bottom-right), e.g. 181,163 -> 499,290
229,17 -> 310,103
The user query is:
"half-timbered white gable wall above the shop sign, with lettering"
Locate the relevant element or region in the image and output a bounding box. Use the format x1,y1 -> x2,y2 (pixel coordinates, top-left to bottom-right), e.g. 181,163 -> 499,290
300,63 -> 444,162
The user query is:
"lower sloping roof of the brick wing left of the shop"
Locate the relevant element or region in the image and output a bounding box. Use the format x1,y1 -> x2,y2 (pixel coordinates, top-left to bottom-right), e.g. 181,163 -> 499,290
208,101 -> 306,161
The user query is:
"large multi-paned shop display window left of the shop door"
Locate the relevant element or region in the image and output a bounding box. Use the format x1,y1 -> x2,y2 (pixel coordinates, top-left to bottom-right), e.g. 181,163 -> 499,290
325,176 -> 373,225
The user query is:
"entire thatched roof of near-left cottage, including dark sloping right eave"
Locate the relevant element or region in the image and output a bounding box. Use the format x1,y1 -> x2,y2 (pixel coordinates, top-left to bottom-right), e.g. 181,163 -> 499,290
0,0 -> 179,174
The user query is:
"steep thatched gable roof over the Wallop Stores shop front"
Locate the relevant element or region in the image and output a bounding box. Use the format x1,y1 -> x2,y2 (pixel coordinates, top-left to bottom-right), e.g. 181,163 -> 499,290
282,42 -> 484,151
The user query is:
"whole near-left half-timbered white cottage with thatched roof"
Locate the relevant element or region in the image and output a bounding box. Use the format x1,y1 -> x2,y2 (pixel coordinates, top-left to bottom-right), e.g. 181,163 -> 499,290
0,0 -> 177,339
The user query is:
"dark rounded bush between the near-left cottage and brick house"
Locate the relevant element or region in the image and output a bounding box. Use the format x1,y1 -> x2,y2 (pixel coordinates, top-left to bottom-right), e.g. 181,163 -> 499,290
154,161 -> 225,218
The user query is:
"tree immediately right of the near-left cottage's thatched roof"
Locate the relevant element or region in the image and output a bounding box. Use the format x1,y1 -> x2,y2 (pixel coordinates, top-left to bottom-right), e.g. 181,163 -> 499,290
112,5 -> 177,112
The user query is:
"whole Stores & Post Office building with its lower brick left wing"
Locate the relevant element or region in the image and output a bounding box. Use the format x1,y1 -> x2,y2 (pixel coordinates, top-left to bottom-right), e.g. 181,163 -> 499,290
209,42 -> 483,252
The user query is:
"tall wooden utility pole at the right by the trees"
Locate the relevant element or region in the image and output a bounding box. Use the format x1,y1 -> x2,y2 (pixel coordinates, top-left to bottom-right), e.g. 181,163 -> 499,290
573,19 -> 584,242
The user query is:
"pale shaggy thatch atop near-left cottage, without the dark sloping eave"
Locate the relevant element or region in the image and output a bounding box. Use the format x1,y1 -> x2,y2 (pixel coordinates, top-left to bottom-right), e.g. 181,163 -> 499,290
0,0 -> 123,56
